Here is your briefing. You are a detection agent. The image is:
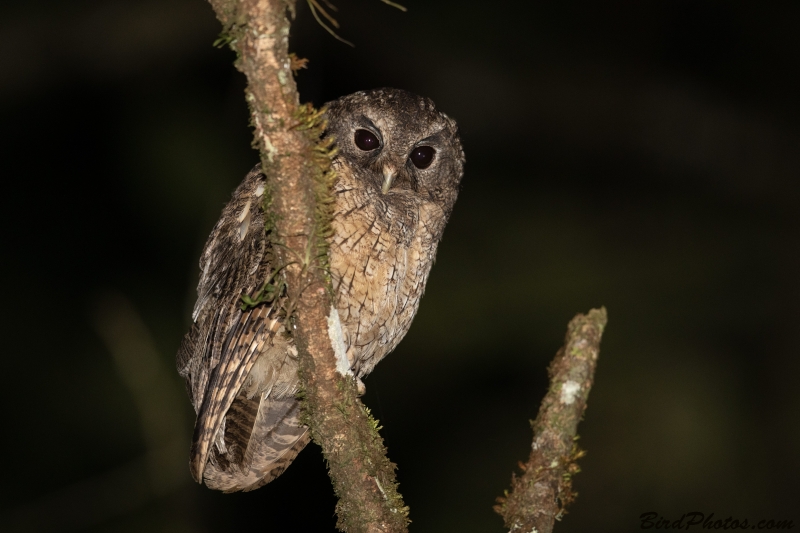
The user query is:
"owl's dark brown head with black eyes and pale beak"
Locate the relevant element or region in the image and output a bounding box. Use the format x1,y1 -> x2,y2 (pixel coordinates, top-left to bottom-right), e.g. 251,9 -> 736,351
327,89 -> 464,220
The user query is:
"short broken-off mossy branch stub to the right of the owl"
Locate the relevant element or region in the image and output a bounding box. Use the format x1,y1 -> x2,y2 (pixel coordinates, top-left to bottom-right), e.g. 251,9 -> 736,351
495,308 -> 608,533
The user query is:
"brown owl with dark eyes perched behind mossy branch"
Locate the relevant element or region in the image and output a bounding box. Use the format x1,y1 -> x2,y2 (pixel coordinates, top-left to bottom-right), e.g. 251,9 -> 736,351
177,89 -> 464,492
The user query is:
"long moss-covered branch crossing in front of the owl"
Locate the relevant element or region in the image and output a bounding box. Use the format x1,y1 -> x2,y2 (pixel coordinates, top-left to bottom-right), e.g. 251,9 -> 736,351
203,0 -> 408,533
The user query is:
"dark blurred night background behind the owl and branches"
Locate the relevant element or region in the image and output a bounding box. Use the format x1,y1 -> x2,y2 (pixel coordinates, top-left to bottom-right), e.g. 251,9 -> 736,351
0,0 -> 800,533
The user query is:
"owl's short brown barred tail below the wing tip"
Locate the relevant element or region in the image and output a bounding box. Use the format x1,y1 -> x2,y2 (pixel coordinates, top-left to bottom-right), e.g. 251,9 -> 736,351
203,394 -> 311,492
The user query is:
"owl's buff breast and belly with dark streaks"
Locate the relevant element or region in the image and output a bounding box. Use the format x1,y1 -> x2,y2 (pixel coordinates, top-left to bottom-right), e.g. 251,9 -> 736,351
330,191 -> 436,376
